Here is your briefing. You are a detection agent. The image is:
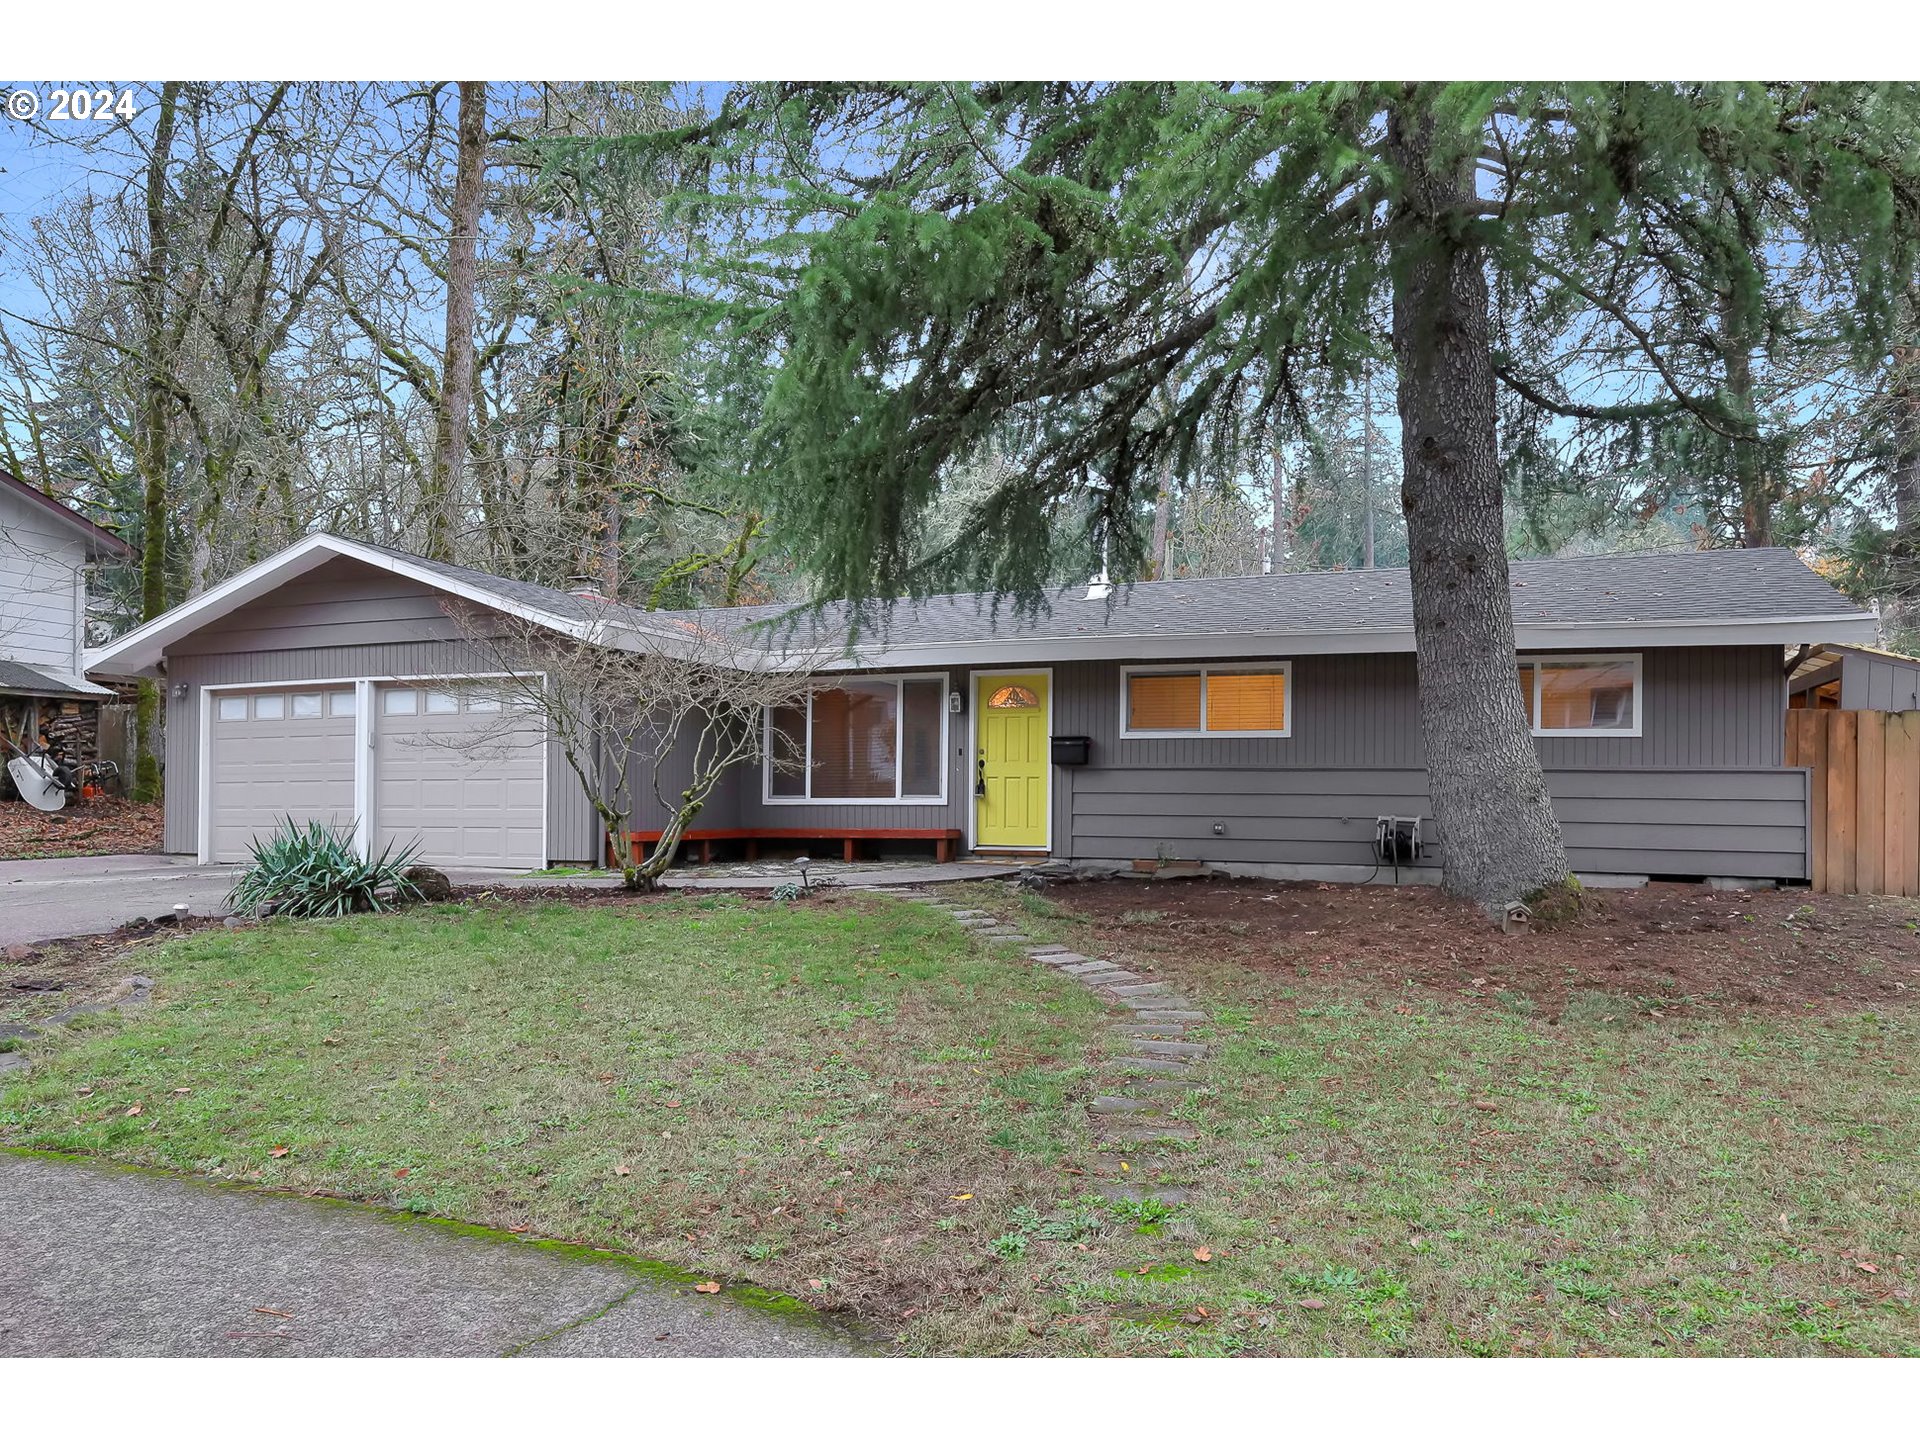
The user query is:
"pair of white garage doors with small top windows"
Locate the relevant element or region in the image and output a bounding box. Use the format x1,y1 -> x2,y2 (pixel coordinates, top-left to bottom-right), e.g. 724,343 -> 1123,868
204,682 -> 547,870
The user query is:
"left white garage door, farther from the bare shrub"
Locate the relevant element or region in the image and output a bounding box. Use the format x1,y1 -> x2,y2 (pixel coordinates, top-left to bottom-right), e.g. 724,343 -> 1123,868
204,685 -> 353,860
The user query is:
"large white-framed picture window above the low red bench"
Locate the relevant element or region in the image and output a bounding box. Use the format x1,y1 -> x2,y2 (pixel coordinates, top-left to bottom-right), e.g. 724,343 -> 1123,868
762,676 -> 947,804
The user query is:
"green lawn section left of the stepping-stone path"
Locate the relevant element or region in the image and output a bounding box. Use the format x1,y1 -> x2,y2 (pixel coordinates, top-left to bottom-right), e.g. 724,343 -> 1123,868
0,897 -> 1100,1348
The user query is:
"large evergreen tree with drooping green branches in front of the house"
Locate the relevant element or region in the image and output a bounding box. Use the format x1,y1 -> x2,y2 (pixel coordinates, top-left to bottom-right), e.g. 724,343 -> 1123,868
645,83 -> 1912,906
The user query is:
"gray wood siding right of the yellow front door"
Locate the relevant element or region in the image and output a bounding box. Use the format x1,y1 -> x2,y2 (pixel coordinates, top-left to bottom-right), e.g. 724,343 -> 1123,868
1054,647 -> 1807,879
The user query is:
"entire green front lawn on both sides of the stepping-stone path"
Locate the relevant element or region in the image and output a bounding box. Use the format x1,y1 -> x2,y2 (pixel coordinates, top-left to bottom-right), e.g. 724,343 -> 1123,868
0,887 -> 1920,1356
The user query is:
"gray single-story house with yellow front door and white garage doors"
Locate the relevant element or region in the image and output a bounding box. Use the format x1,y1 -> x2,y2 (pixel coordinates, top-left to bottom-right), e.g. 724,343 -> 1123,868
90,536 -> 1876,879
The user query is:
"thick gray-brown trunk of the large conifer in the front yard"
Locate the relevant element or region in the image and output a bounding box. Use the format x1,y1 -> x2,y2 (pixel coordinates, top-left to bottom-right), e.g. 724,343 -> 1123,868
1388,100 -> 1567,910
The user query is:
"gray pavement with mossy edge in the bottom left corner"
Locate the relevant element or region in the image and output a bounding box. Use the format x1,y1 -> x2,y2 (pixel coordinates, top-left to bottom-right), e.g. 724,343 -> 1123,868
0,1154 -> 856,1357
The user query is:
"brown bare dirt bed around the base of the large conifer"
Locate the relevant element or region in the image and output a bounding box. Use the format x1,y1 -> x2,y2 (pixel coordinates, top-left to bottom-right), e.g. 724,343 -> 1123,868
1050,879 -> 1920,1018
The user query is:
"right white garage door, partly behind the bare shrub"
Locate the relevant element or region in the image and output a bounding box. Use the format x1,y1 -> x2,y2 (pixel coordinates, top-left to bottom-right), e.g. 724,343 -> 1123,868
372,685 -> 547,870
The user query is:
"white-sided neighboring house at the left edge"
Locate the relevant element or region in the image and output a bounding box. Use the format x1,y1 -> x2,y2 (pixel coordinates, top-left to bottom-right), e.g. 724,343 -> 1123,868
0,470 -> 132,771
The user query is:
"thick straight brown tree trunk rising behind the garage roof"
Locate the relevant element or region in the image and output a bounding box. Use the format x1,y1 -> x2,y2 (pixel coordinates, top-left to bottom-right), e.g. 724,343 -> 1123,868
424,81 -> 486,561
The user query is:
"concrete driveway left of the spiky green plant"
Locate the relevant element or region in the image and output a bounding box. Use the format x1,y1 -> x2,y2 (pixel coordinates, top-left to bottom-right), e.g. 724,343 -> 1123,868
0,854 -> 234,947
